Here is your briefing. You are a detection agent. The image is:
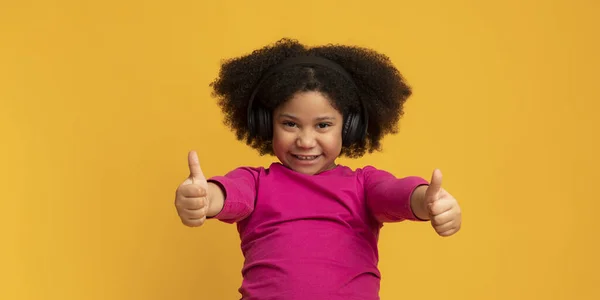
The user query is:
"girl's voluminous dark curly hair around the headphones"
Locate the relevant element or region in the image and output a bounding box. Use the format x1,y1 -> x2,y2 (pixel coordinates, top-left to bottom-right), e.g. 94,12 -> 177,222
210,38 -> 412,158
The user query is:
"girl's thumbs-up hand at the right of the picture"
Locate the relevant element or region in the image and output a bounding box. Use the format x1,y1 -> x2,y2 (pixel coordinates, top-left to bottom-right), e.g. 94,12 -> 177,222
425,169 -> 462,236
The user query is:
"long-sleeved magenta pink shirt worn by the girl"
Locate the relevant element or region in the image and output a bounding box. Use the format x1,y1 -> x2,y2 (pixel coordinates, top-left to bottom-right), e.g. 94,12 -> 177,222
209,163 -> 428,300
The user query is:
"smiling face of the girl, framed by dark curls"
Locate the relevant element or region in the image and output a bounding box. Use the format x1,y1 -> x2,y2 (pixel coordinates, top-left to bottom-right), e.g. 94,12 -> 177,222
273,92 -> 343,175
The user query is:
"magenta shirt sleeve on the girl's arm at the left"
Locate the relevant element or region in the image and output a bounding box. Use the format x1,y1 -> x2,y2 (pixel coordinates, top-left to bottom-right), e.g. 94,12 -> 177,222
207,167 -> 260,223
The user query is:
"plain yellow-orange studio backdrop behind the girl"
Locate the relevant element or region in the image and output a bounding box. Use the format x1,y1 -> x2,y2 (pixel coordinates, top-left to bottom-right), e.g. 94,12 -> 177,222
0,0 -> 600,300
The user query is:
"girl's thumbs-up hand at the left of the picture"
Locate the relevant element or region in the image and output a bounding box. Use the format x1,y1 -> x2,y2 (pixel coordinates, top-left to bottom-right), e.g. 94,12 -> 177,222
175,151 -> 209,227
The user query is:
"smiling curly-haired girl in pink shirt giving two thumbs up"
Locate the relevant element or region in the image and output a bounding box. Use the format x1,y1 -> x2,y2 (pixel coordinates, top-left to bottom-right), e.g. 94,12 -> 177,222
175,39 -> 461,300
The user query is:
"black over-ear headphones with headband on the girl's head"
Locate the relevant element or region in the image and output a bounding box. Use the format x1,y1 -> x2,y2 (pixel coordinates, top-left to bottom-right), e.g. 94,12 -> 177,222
248,56 -> 369,147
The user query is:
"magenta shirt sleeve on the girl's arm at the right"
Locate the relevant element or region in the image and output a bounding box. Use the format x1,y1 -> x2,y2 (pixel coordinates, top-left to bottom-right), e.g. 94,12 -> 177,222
363,166 -> 429,223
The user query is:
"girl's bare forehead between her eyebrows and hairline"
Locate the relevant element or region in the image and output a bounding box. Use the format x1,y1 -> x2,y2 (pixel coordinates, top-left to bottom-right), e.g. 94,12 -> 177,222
275,91 -> 340,117
